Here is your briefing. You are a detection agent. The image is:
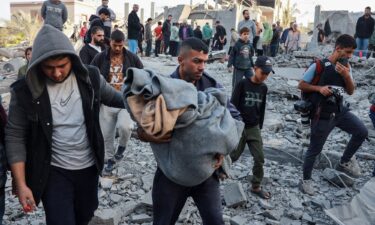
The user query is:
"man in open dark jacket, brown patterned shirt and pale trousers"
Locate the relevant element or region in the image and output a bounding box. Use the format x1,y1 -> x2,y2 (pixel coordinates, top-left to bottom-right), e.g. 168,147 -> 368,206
91,30 -> 143,175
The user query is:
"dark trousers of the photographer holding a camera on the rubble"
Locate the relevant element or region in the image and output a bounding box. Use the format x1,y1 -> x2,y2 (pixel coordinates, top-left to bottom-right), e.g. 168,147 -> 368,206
303,111 -> 368,180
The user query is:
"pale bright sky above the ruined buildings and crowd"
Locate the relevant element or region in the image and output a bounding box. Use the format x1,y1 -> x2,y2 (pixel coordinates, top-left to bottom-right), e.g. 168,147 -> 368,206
0,0 -> 375,25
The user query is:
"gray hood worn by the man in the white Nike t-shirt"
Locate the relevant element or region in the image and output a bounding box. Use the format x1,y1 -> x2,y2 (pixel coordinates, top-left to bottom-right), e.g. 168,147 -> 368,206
26,24 -> 88,99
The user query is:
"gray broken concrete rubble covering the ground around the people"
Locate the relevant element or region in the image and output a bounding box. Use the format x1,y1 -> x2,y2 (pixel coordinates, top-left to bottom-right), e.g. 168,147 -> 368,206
0,41 -> 375,225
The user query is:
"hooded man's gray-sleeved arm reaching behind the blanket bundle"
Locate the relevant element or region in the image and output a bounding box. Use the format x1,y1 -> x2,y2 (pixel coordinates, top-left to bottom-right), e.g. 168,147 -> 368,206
100,75 -> 125,109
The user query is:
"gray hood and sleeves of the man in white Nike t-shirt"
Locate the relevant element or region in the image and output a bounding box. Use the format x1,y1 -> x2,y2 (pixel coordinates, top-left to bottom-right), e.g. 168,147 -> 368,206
5,25 -> 122,164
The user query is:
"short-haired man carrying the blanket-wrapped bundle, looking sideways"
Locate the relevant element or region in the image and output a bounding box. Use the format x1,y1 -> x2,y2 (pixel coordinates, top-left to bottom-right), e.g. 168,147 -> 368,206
146,38 -> 241,225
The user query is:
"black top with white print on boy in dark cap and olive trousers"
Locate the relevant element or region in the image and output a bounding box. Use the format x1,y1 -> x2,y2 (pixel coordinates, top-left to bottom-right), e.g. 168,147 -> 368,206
231,79 -> 268,128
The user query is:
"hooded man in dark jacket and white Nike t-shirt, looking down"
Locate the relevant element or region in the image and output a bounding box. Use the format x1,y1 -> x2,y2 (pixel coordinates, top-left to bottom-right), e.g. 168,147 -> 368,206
5,25 -> 124,225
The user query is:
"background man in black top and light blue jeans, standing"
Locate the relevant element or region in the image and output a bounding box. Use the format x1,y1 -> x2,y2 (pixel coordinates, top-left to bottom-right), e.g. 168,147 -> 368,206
128,4 -> 141,54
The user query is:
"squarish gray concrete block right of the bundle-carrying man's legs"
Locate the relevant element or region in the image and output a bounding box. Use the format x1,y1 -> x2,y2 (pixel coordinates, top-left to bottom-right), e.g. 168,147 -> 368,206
224,182 -> 247,207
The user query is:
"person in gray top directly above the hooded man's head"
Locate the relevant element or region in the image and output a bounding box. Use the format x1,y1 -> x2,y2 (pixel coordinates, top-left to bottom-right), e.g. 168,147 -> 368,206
41,0 -> 68,31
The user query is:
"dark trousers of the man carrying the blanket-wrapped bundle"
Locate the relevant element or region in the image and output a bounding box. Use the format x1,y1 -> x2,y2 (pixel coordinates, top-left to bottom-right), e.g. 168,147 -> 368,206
152,168 -> 224,225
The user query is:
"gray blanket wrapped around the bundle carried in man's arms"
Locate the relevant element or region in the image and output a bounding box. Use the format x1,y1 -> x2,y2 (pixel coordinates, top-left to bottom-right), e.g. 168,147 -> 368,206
123,68 -> 244,187
